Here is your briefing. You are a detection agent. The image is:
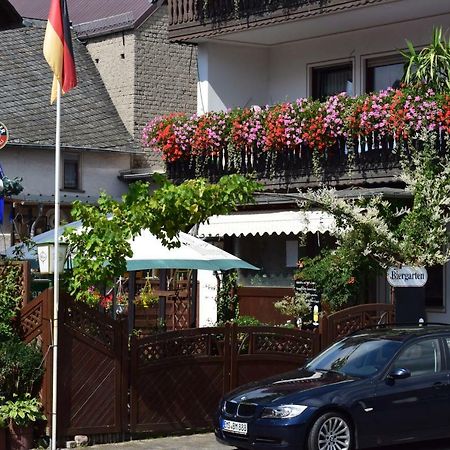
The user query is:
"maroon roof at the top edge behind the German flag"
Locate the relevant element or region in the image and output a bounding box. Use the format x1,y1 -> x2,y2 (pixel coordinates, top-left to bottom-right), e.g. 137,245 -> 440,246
10,0 -> 157,37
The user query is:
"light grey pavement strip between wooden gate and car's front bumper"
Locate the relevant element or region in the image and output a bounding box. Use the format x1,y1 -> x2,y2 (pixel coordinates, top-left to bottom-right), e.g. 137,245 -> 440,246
87,433 -> 232,450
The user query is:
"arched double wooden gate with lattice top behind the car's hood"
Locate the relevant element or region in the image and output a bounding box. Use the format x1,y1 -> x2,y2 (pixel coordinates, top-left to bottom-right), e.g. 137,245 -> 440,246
130,326 -> 320,433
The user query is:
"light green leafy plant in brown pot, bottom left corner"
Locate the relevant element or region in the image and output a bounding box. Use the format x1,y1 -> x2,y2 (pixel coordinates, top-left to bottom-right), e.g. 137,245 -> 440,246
0,393 -> 44,450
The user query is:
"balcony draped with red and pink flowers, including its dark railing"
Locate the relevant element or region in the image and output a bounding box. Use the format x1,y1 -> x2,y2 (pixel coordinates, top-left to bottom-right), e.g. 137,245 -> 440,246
143,87 -> 450,191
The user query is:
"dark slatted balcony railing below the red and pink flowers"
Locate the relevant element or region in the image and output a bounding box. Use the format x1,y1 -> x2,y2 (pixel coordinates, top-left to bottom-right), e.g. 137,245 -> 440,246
167,135 -> 406,186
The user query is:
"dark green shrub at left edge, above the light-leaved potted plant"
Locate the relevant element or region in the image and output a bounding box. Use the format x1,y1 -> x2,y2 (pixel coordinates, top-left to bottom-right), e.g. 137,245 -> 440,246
0,338 -> 44,399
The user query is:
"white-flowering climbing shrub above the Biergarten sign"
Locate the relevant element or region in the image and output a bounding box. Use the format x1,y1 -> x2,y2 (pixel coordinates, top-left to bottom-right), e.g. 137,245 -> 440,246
299,134 -> 450,282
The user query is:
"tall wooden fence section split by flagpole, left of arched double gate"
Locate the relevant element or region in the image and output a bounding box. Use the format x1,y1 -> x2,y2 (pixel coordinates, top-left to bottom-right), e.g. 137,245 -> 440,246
21,289 -> 128,438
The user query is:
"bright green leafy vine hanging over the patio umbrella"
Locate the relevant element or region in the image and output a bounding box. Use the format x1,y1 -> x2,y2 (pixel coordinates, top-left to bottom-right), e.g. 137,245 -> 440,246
66,175 -> 260,299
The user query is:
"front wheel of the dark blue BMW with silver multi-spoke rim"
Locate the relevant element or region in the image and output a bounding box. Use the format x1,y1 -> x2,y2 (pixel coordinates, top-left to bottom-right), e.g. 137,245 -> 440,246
308,412 -> 353,450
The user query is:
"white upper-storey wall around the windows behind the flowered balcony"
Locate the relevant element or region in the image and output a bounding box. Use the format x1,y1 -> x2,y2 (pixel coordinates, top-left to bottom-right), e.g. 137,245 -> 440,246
198,14 -> 450,112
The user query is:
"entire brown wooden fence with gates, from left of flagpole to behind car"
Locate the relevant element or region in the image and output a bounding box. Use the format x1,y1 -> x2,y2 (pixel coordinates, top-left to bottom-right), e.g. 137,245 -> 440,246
21,289 -> 393,442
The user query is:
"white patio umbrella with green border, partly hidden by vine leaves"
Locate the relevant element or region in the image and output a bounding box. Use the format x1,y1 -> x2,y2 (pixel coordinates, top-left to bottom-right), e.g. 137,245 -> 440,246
6,221 -> 259,271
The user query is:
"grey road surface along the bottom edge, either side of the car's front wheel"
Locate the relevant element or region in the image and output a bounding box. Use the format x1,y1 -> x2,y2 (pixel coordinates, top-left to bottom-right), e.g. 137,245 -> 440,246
89,433 -> 450,450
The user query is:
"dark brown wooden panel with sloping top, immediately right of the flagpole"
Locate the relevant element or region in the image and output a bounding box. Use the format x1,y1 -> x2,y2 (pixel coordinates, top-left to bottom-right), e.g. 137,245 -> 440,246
58,298 -> 128,436
